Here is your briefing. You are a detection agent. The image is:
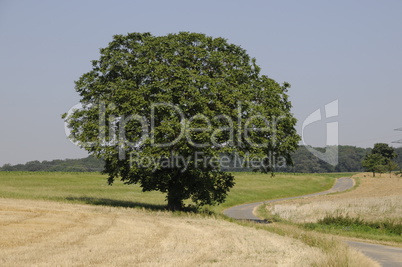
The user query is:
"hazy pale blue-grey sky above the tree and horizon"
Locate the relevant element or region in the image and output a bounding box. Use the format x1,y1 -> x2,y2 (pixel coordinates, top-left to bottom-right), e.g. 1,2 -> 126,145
0,0 -> 402,166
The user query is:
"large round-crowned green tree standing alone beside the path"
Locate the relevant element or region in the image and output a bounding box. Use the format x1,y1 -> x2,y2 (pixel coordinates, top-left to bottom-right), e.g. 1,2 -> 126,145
63,32 -> 300,210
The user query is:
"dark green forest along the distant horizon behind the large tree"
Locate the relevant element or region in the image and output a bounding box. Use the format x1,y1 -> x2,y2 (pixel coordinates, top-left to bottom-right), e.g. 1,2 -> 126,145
0,146 -> 402,173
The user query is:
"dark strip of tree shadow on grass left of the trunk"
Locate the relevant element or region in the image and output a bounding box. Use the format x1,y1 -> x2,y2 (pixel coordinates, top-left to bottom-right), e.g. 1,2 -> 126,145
66,197 -> 167,211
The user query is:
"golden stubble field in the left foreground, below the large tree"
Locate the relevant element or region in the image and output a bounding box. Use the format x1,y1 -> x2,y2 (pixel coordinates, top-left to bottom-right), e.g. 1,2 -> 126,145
0,198 -> 332,266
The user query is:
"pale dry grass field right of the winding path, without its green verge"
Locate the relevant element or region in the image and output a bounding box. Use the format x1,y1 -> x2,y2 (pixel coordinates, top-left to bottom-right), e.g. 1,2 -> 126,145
266,173 -> 402,223
